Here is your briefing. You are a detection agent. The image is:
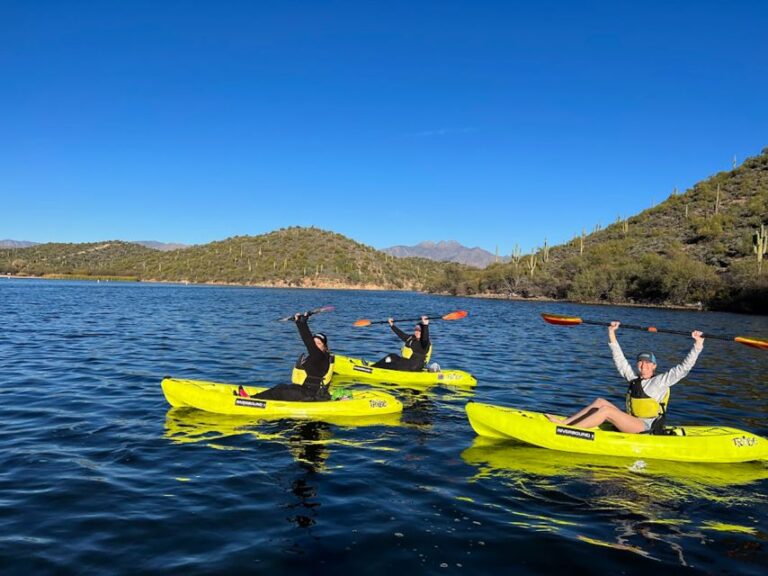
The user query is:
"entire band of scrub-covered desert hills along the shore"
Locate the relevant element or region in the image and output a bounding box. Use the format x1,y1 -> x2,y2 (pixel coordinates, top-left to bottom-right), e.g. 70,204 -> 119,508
0,149 -> 768,314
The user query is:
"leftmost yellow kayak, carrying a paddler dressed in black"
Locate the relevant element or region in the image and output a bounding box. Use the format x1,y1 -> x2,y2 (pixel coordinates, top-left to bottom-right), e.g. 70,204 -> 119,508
161,378 -> 403,422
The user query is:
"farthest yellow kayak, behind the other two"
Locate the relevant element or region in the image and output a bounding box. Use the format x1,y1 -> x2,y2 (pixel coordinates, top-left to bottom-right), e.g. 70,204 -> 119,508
333,354 -> 477,386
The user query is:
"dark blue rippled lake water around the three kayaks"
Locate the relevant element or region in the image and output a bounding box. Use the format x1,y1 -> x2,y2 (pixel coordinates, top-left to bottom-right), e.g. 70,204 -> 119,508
0,279 -> 768,575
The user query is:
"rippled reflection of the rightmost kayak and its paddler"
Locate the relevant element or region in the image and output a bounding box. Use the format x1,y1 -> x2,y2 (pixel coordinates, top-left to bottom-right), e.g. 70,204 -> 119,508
461,437 -> 768,566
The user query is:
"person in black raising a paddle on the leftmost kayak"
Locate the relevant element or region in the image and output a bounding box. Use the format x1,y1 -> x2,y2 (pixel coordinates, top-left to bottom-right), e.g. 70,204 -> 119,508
246,313 -> 331,402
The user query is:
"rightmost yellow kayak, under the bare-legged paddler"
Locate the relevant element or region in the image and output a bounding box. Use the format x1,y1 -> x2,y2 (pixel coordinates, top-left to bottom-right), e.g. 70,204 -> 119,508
466,402 -> 768,463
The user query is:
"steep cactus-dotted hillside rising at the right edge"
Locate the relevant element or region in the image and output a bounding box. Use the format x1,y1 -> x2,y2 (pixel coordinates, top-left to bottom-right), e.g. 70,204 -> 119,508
427,149 -> 768,314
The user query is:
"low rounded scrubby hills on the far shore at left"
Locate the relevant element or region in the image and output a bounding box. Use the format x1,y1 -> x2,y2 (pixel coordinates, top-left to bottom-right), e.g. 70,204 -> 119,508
0,228 -> 444,290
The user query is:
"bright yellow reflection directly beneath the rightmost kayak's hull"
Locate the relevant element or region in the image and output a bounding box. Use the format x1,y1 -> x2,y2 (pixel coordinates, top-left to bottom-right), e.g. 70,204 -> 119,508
461,436 -> 768,487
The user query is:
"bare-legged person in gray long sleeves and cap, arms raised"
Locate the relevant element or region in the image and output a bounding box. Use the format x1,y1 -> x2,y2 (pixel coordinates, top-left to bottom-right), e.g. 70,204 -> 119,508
547,322 -> 704,433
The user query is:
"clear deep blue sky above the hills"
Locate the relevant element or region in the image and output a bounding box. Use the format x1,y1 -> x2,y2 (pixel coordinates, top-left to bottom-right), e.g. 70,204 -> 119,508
0,0 -> 768,254
